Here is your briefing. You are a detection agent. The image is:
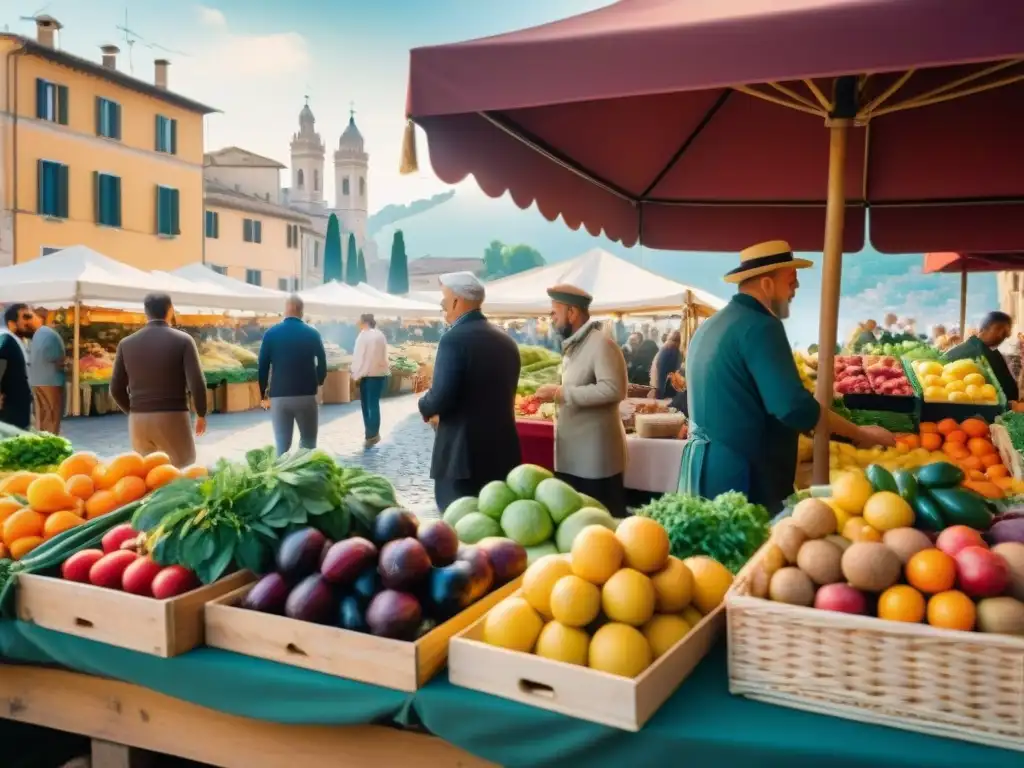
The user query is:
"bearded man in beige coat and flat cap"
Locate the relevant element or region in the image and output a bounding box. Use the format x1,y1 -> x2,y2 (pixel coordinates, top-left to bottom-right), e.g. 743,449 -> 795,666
537,284 -> 627,516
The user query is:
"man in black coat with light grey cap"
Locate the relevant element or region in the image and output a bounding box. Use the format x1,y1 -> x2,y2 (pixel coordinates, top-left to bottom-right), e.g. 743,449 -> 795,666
420,272 -> 521,511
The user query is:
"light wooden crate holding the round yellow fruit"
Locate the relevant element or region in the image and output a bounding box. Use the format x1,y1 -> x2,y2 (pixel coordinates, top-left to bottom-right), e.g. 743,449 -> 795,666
449,593 -> 725,731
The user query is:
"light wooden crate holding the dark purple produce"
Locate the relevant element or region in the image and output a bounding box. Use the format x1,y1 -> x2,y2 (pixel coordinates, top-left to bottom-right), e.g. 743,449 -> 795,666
206,579 -> 520,692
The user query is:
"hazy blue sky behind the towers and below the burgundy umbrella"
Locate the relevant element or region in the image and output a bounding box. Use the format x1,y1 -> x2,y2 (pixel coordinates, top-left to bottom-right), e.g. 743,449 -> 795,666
9,0 -> 996,344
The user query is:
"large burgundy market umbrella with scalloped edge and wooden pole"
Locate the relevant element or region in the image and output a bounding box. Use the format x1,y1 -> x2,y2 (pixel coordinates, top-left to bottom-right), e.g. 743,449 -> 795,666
403,0 -> 1024,482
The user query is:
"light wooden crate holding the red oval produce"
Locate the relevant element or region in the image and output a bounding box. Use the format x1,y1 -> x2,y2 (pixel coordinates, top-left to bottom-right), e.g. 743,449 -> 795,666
17,571 -> 253,657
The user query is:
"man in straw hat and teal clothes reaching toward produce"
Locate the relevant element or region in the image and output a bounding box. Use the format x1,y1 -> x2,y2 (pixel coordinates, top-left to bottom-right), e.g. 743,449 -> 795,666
679,240 -> 895,512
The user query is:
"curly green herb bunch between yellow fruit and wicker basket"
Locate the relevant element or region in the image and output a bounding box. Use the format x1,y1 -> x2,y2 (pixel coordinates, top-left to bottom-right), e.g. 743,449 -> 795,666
637,492 -> 771,573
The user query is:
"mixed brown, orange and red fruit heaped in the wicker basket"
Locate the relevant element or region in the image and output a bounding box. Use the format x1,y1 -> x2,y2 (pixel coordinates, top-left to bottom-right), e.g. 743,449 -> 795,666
751,495 -> 1024,637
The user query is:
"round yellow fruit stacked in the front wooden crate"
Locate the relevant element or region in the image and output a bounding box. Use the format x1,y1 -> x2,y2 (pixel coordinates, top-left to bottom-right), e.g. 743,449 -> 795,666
482,517 -> 732,678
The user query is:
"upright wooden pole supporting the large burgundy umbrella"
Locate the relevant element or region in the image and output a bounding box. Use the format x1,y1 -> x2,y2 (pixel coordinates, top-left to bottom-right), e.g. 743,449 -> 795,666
812,119 -> 851,485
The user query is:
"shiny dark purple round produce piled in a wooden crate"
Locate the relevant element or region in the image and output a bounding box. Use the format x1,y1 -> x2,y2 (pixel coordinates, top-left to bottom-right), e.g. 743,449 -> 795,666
243,508 -> 526,640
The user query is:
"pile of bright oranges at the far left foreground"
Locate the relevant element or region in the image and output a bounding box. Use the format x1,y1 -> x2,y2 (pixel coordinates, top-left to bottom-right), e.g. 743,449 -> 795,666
0,452 -> 206,560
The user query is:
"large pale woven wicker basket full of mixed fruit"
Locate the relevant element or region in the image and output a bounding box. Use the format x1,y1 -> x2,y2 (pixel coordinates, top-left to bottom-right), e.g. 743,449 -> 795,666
726,556 -> 1024,751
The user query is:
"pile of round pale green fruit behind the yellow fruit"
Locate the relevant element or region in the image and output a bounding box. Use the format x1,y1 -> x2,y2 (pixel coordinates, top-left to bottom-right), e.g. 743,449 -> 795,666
443,464 -> 617,563
